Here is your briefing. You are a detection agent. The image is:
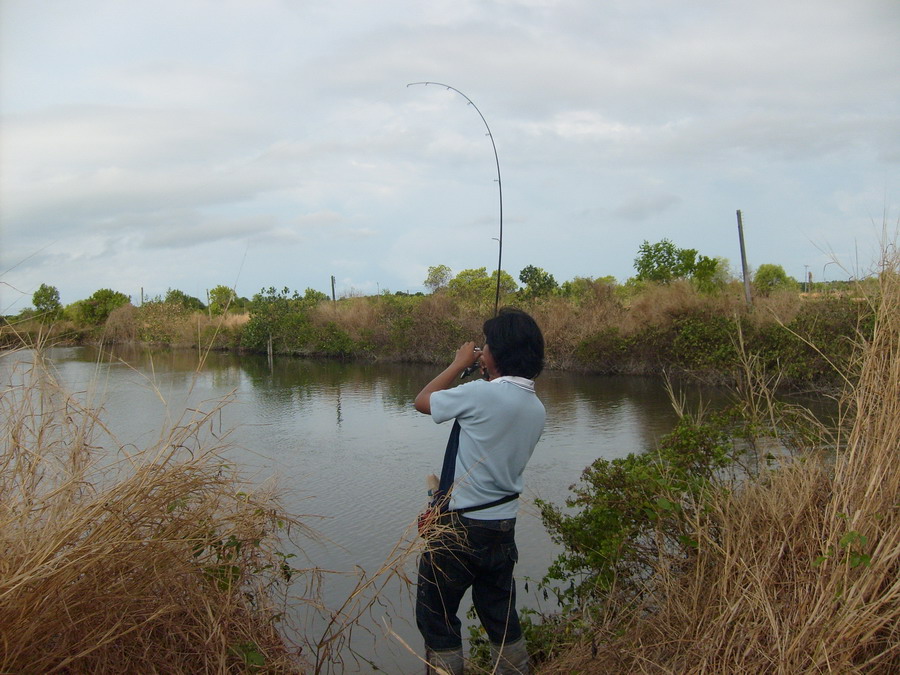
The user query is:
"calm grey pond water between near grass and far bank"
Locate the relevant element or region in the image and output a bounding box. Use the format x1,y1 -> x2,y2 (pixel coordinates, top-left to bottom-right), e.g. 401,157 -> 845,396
7,347 -> 721,673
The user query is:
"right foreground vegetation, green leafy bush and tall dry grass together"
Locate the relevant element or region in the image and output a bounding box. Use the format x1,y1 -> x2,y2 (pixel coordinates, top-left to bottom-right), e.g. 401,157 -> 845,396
526,246 -> 900,675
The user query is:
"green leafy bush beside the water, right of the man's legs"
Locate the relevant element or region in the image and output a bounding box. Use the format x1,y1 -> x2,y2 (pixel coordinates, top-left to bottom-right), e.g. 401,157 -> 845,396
536,416 -> 737,609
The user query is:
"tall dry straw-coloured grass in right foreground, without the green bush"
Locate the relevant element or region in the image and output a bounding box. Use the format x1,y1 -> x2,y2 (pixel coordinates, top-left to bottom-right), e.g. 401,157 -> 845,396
541,254 -> 900,675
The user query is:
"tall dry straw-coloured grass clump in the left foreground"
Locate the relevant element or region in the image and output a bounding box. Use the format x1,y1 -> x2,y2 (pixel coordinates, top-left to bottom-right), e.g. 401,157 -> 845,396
0,349 -> 312,673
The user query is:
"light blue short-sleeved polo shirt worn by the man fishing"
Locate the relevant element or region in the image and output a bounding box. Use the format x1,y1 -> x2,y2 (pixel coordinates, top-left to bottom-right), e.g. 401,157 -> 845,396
430,376 -> 546,520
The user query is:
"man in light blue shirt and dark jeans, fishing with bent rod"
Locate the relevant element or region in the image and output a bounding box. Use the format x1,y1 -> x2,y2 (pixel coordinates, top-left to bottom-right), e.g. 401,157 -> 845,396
415,308 -> 546,675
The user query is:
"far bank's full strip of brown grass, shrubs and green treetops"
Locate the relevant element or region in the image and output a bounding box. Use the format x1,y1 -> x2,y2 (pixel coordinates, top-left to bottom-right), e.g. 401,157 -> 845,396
0,240 -> 874,389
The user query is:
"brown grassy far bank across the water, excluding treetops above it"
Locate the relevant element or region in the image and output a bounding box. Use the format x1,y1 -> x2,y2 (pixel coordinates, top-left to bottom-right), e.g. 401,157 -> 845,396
0,280 -> 873,388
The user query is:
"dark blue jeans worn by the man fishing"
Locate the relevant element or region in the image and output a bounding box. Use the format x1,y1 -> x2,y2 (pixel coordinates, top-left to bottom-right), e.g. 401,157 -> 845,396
416,514 -> 522,651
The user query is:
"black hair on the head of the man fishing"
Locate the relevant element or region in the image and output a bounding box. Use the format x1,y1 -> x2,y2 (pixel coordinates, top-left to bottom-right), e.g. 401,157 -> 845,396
483,307 -> 544,380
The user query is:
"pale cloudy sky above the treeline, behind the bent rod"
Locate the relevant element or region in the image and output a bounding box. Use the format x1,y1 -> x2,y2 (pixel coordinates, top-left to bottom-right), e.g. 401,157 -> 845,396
0,0 -> 900,314
